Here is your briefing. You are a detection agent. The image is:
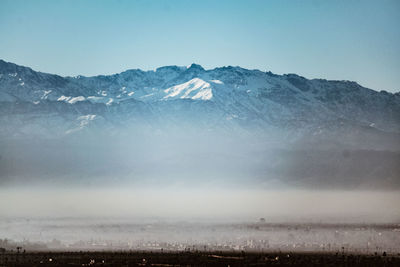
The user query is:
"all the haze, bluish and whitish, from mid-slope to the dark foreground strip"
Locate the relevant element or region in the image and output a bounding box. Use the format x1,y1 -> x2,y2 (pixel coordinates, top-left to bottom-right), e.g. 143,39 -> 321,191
0,129 -> 400,253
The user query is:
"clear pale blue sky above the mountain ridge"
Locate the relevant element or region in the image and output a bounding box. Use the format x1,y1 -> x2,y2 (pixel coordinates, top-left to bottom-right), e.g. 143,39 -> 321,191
0,0 -> 400,92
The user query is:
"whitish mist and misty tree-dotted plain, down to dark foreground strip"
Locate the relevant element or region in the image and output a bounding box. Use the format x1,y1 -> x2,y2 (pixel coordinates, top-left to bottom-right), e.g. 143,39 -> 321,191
0,186 -> 400,254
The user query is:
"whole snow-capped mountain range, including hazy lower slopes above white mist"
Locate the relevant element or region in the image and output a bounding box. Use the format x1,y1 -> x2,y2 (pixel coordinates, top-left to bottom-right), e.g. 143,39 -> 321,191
0,60 -> 400,188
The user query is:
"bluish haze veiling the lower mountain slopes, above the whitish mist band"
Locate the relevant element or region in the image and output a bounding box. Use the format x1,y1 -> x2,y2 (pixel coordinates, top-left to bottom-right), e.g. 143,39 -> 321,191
0,129 -> 400,190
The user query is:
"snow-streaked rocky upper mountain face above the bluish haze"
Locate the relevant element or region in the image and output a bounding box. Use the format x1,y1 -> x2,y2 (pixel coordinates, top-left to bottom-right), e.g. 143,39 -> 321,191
0,61 -> 400,146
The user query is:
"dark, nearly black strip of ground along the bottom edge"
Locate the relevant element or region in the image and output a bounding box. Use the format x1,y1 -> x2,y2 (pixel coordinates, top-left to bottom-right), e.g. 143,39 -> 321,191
0,251 -> 400,267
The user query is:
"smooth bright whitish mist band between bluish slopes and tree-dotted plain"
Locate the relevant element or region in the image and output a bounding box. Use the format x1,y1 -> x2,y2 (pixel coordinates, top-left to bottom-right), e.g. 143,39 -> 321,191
0,187 -> 400,223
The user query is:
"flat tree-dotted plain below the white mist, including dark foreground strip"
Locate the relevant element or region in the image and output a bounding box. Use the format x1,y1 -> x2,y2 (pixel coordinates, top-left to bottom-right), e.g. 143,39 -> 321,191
0,221 -> 400,267
